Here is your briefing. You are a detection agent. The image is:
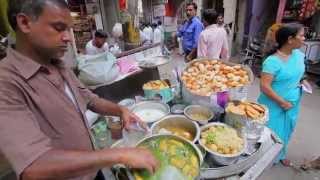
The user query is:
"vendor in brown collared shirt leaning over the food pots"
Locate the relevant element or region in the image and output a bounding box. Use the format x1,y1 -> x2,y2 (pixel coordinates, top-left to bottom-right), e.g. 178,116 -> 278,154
0,0 -> 157,180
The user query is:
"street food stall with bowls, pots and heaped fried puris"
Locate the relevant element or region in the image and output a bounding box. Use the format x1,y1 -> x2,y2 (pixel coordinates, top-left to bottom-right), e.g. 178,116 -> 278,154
87,59 -> 282,180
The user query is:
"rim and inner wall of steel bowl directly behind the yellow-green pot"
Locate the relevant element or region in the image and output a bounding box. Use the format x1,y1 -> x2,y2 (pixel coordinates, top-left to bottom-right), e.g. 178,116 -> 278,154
151,115 -> 200,143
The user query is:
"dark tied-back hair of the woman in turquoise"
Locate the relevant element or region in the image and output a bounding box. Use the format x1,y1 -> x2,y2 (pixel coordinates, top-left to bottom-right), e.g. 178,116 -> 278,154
266,23 -> 303,56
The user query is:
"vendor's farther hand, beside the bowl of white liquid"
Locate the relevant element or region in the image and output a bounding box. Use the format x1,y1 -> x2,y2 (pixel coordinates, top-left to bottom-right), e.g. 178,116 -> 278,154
121,107 -> 148,130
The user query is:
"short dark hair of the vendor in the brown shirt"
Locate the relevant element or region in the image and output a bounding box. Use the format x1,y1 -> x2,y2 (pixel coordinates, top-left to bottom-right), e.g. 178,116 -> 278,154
8,0 -> 68,30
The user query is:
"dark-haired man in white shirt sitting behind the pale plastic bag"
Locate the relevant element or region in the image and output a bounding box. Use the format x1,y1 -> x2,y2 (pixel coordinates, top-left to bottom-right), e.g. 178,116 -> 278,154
86,30 -> 109,55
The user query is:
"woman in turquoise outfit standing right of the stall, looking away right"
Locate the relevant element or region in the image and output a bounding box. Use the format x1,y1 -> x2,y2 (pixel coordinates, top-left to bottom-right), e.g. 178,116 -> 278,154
258,24 -> 305,166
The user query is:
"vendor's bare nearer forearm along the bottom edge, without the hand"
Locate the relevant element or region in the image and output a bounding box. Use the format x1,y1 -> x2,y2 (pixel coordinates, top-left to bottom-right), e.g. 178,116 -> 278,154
21,149 -> 126,180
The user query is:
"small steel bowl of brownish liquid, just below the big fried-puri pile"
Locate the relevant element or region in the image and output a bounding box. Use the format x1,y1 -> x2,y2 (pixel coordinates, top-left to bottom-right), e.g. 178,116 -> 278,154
184,105 -> 214,125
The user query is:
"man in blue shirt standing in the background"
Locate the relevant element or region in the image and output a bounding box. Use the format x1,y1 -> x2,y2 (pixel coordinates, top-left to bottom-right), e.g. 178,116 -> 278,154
177,2 -> 203,62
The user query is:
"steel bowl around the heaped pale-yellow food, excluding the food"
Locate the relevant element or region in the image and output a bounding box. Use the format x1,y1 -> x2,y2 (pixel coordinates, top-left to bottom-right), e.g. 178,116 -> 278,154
199,122 -> 247,165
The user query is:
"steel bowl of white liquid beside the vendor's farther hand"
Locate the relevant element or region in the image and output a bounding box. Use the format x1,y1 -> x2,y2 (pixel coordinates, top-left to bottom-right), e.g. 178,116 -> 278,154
132,101 -> 170,123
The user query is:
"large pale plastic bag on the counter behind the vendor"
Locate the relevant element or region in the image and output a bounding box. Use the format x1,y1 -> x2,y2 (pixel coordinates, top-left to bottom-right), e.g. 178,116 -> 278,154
78,52 -> 119,86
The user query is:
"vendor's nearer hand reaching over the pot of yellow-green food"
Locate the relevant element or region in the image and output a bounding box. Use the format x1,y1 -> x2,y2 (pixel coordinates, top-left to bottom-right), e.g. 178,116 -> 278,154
121,148 -> 159,174
